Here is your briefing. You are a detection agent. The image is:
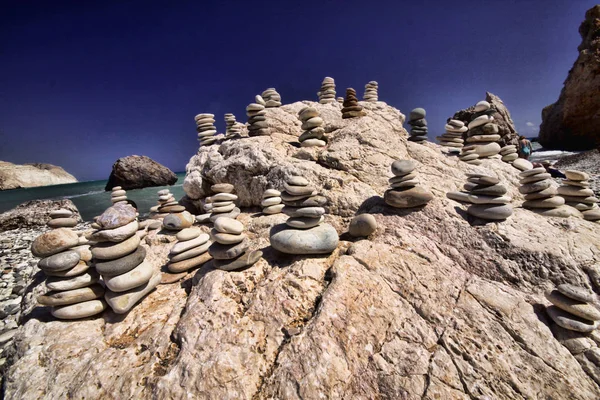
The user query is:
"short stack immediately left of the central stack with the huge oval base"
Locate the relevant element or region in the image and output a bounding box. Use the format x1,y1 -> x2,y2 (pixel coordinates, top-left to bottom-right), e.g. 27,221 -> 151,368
208,217 -> 263,271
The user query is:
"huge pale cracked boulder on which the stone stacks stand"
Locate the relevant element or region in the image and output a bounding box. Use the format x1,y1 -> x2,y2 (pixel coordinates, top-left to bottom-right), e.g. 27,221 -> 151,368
4,102 -> 600,399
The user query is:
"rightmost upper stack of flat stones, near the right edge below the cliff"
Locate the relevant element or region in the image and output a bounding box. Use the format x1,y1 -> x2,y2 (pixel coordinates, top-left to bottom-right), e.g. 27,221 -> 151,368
558,170 -> 600,221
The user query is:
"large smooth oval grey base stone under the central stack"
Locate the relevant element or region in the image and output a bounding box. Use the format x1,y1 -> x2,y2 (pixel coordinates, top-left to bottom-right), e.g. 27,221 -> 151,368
270,224 -> 339,254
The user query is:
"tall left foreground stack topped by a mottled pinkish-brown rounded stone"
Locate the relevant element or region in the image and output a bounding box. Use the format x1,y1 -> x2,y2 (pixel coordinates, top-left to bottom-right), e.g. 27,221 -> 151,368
88,204 -> 161,314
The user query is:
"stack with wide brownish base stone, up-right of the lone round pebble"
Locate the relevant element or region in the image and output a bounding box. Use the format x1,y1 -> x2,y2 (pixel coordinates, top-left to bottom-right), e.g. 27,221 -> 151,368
383,160 -> 433,208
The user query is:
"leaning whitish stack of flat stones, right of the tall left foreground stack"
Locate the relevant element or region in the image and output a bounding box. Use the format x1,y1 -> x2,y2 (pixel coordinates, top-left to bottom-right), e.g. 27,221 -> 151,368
167,226 -> 212,274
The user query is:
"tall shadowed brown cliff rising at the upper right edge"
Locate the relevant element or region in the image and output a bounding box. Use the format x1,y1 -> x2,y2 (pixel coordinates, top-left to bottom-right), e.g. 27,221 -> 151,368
539,5 -> 600,150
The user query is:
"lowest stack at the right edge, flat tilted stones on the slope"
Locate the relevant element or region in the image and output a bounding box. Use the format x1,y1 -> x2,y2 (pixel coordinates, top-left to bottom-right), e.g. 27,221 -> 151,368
545,284 -> 600,333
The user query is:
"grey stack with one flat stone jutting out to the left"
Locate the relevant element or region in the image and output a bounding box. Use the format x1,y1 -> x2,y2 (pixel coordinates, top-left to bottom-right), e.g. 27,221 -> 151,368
446,172 -> 513,221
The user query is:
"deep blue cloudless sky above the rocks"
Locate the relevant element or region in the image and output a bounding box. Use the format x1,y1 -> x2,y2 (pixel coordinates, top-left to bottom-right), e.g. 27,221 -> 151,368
0,0 -> 596,180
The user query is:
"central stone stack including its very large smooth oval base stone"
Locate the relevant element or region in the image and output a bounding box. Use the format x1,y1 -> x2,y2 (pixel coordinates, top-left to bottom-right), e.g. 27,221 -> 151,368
270,176 -> 339,254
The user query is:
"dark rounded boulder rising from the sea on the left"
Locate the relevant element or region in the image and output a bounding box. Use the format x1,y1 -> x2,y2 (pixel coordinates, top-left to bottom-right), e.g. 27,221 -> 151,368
105,156 -> 177,190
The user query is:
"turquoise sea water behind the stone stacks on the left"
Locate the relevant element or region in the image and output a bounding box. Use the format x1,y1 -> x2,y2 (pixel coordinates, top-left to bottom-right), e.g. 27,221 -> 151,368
0,172 -> 185,221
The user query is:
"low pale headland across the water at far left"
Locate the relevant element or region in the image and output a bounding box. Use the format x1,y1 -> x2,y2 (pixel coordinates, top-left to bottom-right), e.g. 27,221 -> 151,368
0,161 -> 77,190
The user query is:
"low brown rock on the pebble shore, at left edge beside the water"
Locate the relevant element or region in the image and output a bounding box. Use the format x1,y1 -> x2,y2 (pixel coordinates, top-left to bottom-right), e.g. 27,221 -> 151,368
0,199 -> 81,232
